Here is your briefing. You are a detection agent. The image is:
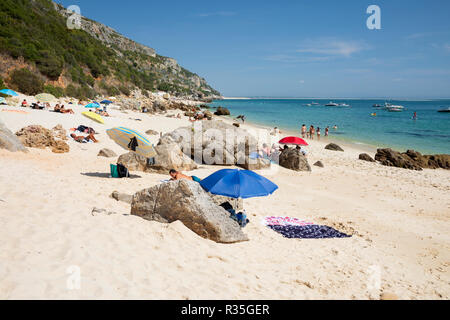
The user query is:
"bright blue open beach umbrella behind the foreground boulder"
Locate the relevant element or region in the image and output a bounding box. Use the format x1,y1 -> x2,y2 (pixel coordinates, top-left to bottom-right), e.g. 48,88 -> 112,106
200,169 -> 278,199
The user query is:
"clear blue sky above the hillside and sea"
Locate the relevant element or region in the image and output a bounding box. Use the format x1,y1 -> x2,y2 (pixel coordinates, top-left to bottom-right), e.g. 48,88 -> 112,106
60,0 -> 450,98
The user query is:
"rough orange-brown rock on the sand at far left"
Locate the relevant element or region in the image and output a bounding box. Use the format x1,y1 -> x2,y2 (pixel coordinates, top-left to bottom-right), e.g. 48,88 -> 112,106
16,125 -> 70,153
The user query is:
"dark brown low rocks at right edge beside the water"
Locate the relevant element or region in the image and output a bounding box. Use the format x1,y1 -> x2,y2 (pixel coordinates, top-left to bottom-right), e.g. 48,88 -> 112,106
375,149 -> 450,171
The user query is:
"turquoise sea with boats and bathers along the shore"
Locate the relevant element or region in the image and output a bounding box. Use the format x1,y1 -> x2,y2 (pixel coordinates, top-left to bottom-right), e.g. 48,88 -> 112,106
210,99 -> 450,154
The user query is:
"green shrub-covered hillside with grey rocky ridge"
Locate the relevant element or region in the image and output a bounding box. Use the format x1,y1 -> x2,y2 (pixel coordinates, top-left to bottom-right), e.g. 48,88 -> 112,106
0,0 -> 220,100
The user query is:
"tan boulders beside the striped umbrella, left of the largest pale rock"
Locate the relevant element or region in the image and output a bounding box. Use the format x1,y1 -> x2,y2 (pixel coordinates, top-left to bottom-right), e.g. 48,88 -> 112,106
117,143 -> 197,173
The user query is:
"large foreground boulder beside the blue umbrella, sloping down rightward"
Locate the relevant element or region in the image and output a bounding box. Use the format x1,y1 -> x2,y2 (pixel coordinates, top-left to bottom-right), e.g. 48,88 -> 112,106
131,179 -> 248,243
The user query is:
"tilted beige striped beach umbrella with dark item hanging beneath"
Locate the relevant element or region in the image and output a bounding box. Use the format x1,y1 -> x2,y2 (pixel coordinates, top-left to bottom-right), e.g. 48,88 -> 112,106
106,127 -> 156,158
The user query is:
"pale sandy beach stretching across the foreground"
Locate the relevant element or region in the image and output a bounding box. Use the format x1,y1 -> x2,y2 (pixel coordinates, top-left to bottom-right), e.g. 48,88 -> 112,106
0,99 -> 450,299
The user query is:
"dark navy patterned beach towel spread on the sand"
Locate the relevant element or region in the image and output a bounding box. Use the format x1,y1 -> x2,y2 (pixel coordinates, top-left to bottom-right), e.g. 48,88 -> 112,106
269,225 -> 351,239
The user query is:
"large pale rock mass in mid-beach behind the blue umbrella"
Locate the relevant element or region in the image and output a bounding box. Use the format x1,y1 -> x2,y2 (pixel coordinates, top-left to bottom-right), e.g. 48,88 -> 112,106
159,121 -> 257,165
